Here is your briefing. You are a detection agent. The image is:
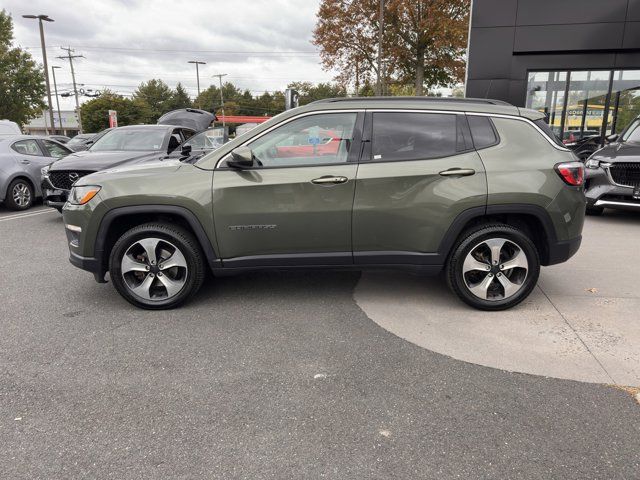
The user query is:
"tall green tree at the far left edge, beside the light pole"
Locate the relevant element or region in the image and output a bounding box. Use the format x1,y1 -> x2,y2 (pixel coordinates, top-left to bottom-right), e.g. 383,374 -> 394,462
0,10 -> 47,126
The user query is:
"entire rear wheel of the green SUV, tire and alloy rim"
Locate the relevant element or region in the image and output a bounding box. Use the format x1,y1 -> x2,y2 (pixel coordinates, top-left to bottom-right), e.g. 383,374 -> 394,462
446,224 -> 540,310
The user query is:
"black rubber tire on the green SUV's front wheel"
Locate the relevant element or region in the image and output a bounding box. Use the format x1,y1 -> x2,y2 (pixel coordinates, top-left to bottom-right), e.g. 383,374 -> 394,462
109,223 -> 205,310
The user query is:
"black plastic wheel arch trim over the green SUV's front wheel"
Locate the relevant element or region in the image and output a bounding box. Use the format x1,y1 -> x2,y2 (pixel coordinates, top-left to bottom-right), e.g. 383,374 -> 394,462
94,205 -> 220,276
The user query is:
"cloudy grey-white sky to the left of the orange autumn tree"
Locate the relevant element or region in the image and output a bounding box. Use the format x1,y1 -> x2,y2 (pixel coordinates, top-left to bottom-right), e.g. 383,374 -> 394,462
0,0 -> 334,110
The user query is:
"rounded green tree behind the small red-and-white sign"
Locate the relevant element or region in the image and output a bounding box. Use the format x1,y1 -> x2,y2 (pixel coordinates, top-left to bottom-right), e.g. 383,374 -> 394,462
81,90 -> 151,132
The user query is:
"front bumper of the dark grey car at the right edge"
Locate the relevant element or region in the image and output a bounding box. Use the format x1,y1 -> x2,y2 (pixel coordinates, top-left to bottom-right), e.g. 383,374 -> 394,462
585,167 -> 640,210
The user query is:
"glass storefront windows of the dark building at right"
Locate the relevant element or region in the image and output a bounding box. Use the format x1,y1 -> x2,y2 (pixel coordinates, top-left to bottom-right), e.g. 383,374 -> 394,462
526,70 -> 640,144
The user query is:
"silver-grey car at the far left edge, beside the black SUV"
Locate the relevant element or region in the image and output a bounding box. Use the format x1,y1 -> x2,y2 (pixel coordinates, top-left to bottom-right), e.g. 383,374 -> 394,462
0,135 -> 72,210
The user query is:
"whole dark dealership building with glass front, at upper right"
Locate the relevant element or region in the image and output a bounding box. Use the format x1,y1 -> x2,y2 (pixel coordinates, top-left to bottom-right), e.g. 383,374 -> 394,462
466,0 -> 640,141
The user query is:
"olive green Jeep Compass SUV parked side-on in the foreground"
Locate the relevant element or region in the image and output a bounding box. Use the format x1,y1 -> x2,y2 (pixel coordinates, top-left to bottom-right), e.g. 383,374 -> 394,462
63,97 -> 585,310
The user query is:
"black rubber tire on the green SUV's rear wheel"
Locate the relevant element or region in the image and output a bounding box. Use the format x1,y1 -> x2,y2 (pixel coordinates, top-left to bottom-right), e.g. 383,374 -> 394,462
446,224 -> 540,310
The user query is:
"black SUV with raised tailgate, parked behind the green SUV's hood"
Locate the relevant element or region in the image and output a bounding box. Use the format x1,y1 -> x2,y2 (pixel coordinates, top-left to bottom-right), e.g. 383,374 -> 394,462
42,109 -> 215,211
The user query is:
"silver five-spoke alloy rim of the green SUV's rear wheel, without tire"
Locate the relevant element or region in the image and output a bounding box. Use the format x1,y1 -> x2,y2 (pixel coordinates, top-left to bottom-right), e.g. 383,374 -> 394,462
462,238 -> 529,301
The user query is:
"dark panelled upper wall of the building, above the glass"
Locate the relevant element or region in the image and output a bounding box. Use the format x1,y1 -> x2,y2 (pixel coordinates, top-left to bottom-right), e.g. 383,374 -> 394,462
466,0 -> 640,106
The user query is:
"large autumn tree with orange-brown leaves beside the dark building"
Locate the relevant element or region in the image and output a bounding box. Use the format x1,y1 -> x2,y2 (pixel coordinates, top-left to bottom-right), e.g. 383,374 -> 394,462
313,0 -> 470,95
